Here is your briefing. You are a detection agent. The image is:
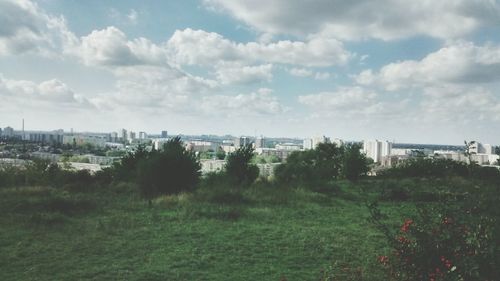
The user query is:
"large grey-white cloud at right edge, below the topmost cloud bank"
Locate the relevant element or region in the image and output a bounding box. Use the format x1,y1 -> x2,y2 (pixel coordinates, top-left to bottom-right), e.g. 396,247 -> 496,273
355,42 -> 500,91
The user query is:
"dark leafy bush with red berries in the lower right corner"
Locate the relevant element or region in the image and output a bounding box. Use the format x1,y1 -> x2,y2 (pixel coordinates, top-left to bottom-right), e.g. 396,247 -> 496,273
369,186 -> 500,281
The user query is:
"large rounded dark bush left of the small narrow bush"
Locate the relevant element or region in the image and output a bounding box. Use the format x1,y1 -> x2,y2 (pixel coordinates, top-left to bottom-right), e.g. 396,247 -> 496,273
137,137 -> 201,198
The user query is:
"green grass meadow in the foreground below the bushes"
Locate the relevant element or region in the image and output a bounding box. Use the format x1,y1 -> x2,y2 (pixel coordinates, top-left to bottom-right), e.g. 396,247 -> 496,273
0,182 -> 424,281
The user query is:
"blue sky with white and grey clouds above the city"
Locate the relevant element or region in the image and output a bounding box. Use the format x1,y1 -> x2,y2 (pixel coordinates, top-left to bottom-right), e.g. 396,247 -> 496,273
0,0 -> 500,144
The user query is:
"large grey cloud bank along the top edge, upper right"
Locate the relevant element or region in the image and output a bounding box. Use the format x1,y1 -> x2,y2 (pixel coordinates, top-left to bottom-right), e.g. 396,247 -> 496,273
204,0 -> 500,40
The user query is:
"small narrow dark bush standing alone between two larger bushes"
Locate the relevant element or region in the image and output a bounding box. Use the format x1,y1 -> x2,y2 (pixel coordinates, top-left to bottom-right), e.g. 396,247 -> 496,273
225,145 -> 259,185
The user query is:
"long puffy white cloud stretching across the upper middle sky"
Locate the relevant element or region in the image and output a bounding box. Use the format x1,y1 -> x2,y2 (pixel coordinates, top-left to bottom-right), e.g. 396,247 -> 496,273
167,28 -> 353,67
